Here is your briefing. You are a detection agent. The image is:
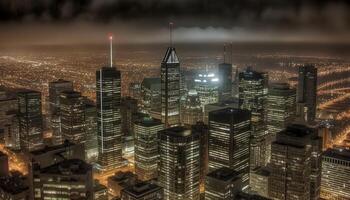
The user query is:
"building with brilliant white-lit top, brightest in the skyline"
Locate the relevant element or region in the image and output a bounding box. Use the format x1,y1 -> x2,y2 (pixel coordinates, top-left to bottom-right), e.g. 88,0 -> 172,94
194,71 -> 220,108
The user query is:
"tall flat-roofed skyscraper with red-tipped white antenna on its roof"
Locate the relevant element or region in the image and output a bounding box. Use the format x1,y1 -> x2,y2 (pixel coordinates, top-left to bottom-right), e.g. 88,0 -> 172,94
96,38 -> 122,170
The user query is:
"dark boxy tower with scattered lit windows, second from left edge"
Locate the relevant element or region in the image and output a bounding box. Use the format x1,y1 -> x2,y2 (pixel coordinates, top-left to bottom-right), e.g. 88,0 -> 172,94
17,90 -> 43,151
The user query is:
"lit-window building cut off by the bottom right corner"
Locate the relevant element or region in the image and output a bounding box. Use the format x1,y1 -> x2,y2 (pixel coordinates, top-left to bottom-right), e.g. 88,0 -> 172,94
321,149 -> 350,199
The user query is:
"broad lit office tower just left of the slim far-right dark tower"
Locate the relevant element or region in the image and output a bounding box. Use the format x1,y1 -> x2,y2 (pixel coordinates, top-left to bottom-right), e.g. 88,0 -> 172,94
266,83 -> 296,161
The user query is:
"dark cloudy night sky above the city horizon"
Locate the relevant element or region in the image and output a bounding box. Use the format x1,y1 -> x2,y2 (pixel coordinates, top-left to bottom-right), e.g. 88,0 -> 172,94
0,0 -> 350,45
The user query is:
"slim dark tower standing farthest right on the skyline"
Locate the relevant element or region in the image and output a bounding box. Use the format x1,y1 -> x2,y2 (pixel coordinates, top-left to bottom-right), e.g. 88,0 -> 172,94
297,65 -> 317,123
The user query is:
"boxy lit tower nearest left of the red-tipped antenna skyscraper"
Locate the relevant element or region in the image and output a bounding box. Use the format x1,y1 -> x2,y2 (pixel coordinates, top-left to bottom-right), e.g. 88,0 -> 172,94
59,91 -> 86,144
